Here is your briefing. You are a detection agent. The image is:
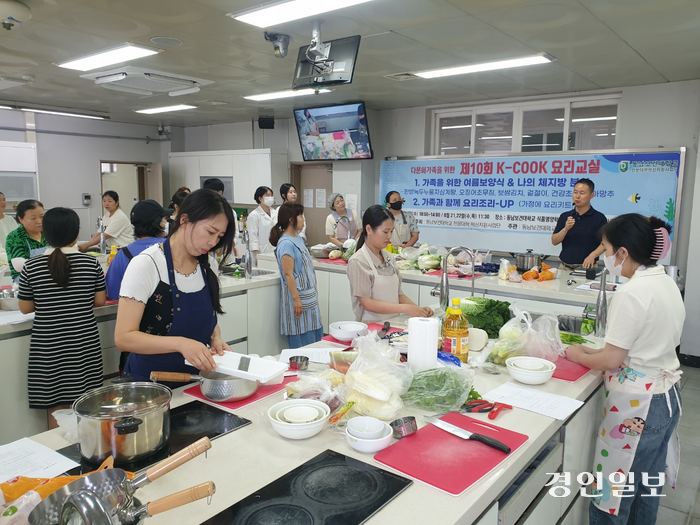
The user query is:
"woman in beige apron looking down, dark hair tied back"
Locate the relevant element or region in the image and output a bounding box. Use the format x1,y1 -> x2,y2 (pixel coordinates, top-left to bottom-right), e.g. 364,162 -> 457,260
347,204 -> 433,322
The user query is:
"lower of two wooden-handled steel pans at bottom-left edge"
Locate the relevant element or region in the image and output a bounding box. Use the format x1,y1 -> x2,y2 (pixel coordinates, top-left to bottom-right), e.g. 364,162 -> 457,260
60,481 -> 216,525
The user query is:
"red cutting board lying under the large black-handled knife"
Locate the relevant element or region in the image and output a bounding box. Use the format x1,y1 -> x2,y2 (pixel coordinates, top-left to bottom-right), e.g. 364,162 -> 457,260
374,412 -> 528,496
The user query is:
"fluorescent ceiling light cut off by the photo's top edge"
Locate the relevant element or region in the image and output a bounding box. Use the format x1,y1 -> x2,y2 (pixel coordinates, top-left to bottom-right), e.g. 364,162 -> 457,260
228,0 -> 370,27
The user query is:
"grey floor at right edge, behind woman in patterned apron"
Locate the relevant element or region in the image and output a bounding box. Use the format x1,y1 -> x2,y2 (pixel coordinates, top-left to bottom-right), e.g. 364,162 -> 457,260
656,367 -> 700,525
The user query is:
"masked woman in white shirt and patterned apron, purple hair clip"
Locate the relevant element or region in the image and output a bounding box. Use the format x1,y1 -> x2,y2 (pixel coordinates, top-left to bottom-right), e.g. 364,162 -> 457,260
566,214 -> 685,525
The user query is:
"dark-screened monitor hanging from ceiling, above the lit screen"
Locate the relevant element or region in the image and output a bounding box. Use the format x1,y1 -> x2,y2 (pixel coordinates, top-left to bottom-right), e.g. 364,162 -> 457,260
292,35 -> 360,89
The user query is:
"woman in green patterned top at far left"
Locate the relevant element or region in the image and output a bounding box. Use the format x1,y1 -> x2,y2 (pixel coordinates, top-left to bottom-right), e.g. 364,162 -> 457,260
5,199 -> 49,282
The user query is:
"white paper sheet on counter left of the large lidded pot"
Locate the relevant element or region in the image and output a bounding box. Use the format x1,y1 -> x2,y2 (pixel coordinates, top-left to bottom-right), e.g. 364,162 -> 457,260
0,438 -> 79,483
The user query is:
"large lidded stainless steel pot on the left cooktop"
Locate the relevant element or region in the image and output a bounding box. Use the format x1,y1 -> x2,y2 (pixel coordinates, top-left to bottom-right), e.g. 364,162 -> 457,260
73,382 -> 172,464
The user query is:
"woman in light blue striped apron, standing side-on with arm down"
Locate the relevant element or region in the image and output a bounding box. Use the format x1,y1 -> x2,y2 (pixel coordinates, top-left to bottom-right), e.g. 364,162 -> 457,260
270,202 -> 323,348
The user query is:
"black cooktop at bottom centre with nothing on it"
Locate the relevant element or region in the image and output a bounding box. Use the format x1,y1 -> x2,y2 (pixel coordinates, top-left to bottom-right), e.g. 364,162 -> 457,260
203,450 -> 413,525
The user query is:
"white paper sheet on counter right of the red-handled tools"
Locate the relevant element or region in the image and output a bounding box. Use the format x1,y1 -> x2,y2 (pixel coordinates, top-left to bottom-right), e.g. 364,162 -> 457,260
484,382 -> 583,421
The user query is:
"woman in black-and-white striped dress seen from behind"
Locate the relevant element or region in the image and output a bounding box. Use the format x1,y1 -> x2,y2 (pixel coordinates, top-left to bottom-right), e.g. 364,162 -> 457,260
19,208 -> 107,428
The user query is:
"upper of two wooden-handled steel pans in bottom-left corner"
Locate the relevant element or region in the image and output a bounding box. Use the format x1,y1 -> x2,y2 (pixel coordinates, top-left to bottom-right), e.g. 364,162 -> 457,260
29,437 -> 211,525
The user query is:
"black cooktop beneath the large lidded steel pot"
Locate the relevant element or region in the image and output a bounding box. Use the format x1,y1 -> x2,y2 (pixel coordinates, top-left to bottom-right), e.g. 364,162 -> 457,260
56,401 -> 250,476
